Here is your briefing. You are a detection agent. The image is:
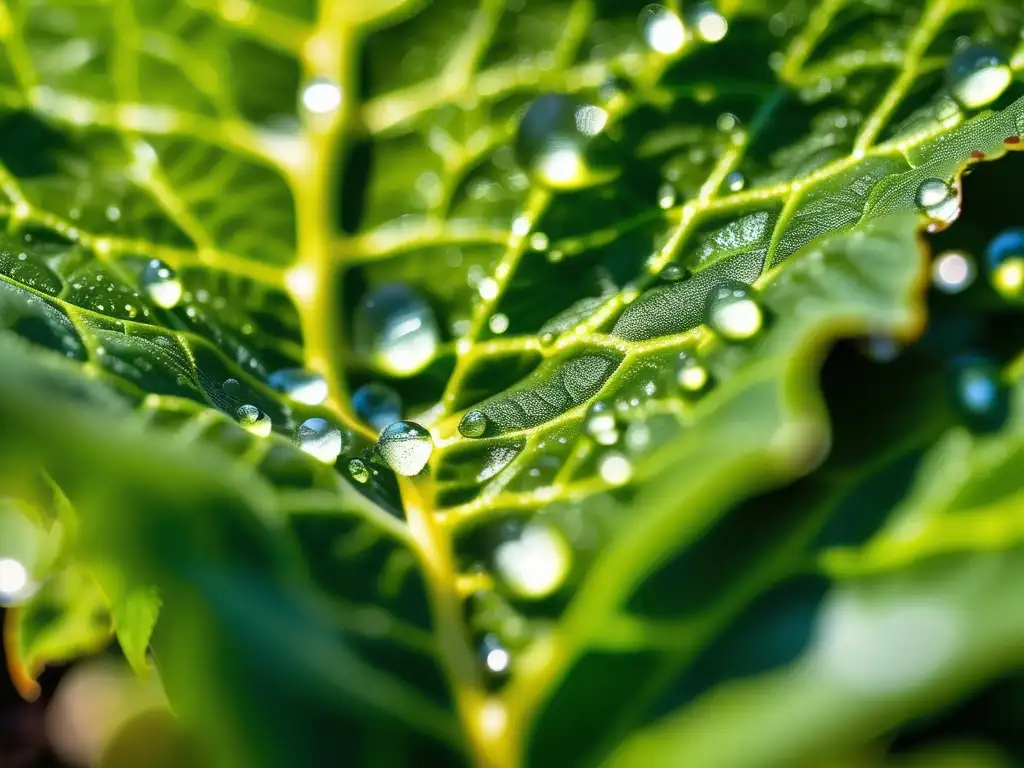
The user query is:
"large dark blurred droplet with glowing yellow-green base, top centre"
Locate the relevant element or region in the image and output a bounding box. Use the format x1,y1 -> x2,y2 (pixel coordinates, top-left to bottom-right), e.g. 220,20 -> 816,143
515,93 -> 611,189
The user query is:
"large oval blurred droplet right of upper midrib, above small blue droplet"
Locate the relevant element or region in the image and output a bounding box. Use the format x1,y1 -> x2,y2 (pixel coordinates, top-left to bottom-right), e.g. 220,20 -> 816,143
352,283 -> 440,376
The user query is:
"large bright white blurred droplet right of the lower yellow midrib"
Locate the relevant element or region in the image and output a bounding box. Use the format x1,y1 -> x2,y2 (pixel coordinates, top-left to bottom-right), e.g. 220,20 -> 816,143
495,524 -> 572,599
